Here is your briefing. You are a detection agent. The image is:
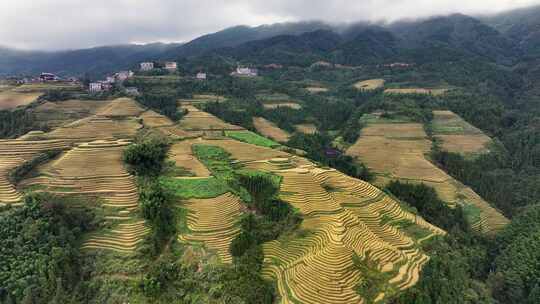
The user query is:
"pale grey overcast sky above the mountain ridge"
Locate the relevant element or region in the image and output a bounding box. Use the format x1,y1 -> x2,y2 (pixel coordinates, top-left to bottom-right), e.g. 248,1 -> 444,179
0,0 -> 540,50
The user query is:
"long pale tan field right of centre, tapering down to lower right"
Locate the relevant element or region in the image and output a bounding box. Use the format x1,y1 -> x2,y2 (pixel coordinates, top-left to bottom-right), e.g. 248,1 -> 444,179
347,114 -> 508,232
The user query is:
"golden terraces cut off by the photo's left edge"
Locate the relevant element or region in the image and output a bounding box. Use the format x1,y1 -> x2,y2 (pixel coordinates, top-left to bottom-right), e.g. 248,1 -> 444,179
0,140 -> 67,204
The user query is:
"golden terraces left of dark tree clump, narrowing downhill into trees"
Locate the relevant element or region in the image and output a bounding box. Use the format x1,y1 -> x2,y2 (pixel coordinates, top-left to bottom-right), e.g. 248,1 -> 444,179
22,140 -> 149,253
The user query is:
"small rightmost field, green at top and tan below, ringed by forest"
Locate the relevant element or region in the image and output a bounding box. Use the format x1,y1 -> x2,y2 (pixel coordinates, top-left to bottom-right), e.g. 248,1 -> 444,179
432,111 -> 492,154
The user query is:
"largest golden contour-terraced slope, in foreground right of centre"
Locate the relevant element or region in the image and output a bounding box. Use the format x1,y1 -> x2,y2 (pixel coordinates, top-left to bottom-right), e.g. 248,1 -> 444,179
263,165 -> 444,303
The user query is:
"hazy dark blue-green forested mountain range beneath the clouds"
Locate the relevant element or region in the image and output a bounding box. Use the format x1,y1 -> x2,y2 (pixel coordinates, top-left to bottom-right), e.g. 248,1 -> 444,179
0,7 -> 540,77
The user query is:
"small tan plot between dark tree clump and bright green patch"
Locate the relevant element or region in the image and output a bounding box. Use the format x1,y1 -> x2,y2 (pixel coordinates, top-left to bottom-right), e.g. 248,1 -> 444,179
169,140 -> 210,177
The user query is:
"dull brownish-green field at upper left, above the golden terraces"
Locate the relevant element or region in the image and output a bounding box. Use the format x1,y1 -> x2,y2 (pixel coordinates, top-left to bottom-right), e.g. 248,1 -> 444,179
32,100 -> 110,129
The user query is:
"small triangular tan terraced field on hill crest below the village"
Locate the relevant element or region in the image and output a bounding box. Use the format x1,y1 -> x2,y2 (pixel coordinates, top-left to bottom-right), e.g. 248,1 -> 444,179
178,105 -> 244,131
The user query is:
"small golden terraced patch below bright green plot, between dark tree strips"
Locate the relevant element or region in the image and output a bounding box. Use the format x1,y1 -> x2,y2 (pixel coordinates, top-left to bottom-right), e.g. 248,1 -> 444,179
178,193 -> 242,263
